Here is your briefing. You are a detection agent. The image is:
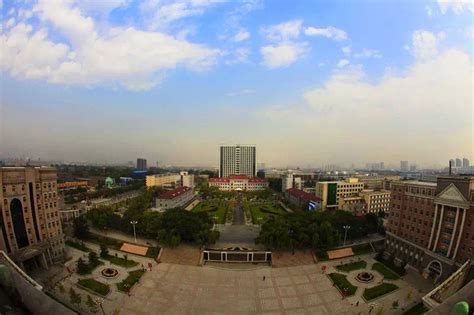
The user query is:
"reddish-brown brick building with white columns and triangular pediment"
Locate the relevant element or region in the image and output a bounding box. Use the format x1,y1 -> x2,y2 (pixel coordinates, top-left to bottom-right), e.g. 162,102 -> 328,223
386,176 -> 474,281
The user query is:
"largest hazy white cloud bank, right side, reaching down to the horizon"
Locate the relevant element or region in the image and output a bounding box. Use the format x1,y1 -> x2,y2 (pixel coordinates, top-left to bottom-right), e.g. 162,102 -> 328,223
257,50 -> 474,163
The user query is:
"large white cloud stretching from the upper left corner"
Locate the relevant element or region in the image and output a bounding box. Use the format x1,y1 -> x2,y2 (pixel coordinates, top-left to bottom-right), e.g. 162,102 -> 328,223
0,0 -> 219,90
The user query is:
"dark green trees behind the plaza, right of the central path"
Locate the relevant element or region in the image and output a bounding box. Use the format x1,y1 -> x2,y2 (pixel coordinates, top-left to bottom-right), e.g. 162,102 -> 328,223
256,211 -> 379,250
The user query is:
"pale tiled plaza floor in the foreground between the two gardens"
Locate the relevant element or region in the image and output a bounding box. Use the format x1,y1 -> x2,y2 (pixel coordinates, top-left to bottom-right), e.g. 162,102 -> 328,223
120,263 -> 354,314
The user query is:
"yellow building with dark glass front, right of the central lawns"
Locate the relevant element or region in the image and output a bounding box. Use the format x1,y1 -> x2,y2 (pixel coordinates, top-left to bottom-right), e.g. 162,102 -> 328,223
316,178 -> 364,209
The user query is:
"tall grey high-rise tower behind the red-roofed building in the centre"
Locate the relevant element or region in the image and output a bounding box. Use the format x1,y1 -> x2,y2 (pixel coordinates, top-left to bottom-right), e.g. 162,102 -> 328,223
219,144 -> 257,177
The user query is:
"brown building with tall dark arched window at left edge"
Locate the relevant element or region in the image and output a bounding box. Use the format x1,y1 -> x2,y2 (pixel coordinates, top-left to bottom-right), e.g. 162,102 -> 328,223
0,167 -> 64,270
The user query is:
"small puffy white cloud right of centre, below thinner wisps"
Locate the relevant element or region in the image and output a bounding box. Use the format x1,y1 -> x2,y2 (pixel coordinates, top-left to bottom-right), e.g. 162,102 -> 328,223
260,42 -> 310,69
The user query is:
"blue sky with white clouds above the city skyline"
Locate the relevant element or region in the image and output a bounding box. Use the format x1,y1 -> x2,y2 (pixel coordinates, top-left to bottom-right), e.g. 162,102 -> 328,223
0,0 -> 474,166
